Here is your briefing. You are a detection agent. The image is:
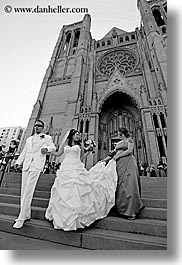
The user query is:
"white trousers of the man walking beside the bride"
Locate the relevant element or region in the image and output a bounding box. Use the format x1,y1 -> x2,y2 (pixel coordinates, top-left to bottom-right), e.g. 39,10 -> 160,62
17,170 -> 40,220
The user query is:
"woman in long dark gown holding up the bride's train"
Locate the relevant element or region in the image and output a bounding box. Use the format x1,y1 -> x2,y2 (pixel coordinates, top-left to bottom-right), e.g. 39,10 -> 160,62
105,128 -> 144,220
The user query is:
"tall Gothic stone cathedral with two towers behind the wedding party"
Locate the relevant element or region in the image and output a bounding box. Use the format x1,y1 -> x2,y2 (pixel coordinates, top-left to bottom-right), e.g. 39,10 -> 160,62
21,0 -> 167,167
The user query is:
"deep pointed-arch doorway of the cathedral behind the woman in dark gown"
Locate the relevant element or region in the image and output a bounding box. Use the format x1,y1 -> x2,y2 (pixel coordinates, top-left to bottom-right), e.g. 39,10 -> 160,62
98,91 -> 147,163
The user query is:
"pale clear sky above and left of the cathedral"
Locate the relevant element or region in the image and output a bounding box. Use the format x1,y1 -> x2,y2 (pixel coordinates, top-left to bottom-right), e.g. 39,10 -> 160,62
0,0 -> 140,128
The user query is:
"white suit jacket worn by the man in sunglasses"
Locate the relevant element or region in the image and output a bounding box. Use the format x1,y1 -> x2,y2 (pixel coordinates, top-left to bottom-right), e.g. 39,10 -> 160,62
16,134 -> 56,171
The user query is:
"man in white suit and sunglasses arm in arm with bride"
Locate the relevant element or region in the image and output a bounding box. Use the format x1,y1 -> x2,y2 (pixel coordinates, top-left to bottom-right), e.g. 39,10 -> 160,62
13,120 -> 56,229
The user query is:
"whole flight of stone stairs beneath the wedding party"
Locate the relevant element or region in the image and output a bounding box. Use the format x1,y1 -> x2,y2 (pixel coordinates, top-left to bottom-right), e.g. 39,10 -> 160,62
0,173 -> 167,250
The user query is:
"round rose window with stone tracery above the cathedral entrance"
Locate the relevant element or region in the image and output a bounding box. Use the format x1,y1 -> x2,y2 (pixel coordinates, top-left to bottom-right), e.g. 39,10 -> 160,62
98,50 -> 137,76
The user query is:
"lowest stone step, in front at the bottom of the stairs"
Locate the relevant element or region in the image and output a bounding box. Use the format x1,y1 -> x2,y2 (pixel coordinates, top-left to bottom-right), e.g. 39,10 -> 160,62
0,214 -> 167,250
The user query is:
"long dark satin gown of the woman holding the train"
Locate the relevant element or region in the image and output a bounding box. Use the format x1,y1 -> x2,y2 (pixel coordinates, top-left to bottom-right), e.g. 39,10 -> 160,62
115,141 -> 144,218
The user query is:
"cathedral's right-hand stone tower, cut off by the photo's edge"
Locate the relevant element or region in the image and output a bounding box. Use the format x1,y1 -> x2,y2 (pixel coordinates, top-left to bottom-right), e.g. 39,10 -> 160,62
137,0 -> 167,164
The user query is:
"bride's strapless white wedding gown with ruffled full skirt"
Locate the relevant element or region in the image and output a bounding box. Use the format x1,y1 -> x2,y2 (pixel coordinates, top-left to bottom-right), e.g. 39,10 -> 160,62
45,145 -> 117,231
